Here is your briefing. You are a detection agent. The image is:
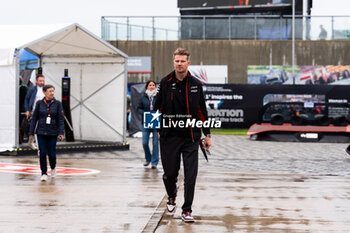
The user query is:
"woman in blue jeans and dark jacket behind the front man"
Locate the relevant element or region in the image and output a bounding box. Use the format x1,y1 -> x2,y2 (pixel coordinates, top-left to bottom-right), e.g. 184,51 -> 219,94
137,80 -> 159,169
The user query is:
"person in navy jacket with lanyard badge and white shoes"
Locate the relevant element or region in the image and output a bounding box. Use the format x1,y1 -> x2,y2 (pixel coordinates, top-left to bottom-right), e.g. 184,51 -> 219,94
29,85 -> 64,181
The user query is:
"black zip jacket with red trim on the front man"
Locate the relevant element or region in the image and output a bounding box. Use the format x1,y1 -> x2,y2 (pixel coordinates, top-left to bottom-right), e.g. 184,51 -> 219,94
155,71 -> 210,141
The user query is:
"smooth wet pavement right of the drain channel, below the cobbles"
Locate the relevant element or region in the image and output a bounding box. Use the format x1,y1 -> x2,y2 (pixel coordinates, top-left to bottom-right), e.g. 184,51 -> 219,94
156,170 -> 350,232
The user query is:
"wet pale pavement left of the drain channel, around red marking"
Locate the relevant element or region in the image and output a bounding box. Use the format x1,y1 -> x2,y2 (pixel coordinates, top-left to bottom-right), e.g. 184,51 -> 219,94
0,157 -> 164,232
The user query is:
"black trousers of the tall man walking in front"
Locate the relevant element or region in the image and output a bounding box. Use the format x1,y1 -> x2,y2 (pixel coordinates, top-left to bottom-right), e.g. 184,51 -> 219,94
160,135 -> 199,211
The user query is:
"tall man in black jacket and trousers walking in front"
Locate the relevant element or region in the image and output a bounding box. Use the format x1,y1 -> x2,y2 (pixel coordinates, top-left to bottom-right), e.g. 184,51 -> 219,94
155,48 -> 211,222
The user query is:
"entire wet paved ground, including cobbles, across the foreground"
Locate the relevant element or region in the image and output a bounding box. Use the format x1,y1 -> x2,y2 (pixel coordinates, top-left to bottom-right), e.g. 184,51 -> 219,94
0,135 -> 350,233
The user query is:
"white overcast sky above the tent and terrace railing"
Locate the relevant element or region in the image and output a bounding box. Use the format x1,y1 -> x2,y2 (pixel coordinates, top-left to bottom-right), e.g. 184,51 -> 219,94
0,0 -> 350,35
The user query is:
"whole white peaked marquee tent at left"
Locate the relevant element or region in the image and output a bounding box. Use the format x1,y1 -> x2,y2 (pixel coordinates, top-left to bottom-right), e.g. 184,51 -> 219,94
0,24 -> 127,152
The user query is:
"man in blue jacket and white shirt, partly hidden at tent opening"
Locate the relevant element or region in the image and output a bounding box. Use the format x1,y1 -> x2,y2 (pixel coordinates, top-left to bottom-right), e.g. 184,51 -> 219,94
24,74 -> 45,150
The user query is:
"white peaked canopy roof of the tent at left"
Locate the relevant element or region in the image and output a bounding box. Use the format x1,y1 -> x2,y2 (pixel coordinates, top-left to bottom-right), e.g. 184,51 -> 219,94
0,23 -> 127,57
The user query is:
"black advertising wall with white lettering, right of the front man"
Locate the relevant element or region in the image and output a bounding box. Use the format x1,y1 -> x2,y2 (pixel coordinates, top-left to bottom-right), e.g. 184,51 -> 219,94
203,84 -> 350,128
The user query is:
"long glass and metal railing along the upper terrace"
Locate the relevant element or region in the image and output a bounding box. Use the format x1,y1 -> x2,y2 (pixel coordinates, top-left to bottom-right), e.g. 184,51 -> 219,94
101,15 -> 350,40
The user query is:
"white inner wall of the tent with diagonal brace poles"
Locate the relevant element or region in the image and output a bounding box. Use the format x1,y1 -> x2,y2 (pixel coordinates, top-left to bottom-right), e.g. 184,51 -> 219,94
42,57 -> 125,141
